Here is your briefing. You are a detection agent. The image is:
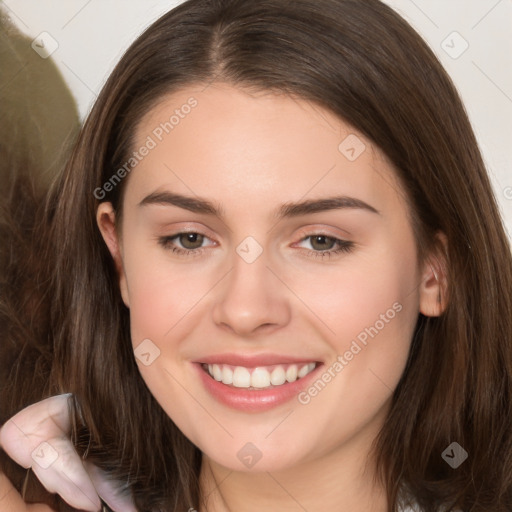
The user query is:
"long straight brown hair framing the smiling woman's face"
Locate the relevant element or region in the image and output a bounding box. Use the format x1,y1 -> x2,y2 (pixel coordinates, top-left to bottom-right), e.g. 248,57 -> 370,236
2,0 -> 512,512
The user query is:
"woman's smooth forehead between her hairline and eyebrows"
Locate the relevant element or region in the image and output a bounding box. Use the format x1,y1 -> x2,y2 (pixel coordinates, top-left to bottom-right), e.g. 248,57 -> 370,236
127,84 -> 402,219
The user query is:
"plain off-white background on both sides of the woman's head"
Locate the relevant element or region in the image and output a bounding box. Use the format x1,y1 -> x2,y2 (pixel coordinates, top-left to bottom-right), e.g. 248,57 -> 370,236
3,0 -> 512,239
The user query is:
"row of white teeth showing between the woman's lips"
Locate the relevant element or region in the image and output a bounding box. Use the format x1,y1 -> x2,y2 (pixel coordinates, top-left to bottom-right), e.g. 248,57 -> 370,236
201,361 -> 319,390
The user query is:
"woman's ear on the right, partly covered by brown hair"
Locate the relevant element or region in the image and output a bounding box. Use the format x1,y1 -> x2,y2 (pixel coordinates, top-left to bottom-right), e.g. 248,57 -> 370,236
419,232 -> 448,316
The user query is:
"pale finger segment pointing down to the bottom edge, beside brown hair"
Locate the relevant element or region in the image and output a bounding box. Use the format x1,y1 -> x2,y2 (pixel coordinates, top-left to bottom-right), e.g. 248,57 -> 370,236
32,438 -> 101,512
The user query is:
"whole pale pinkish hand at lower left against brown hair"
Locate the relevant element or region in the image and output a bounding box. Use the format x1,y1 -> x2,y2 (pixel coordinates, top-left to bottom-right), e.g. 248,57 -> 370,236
0,394 -> 136,512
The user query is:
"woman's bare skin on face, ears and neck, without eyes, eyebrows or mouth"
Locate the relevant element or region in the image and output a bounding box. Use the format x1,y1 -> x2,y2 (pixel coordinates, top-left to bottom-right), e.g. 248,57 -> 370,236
97,83 -> 444,512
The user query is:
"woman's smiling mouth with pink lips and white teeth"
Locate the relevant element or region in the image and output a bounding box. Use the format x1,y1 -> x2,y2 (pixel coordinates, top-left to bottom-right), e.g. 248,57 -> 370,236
193,355 -> 323,413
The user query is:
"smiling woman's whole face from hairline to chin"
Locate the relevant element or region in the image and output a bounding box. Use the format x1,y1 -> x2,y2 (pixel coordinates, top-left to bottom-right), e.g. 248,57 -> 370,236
98,84 -> 438,471
